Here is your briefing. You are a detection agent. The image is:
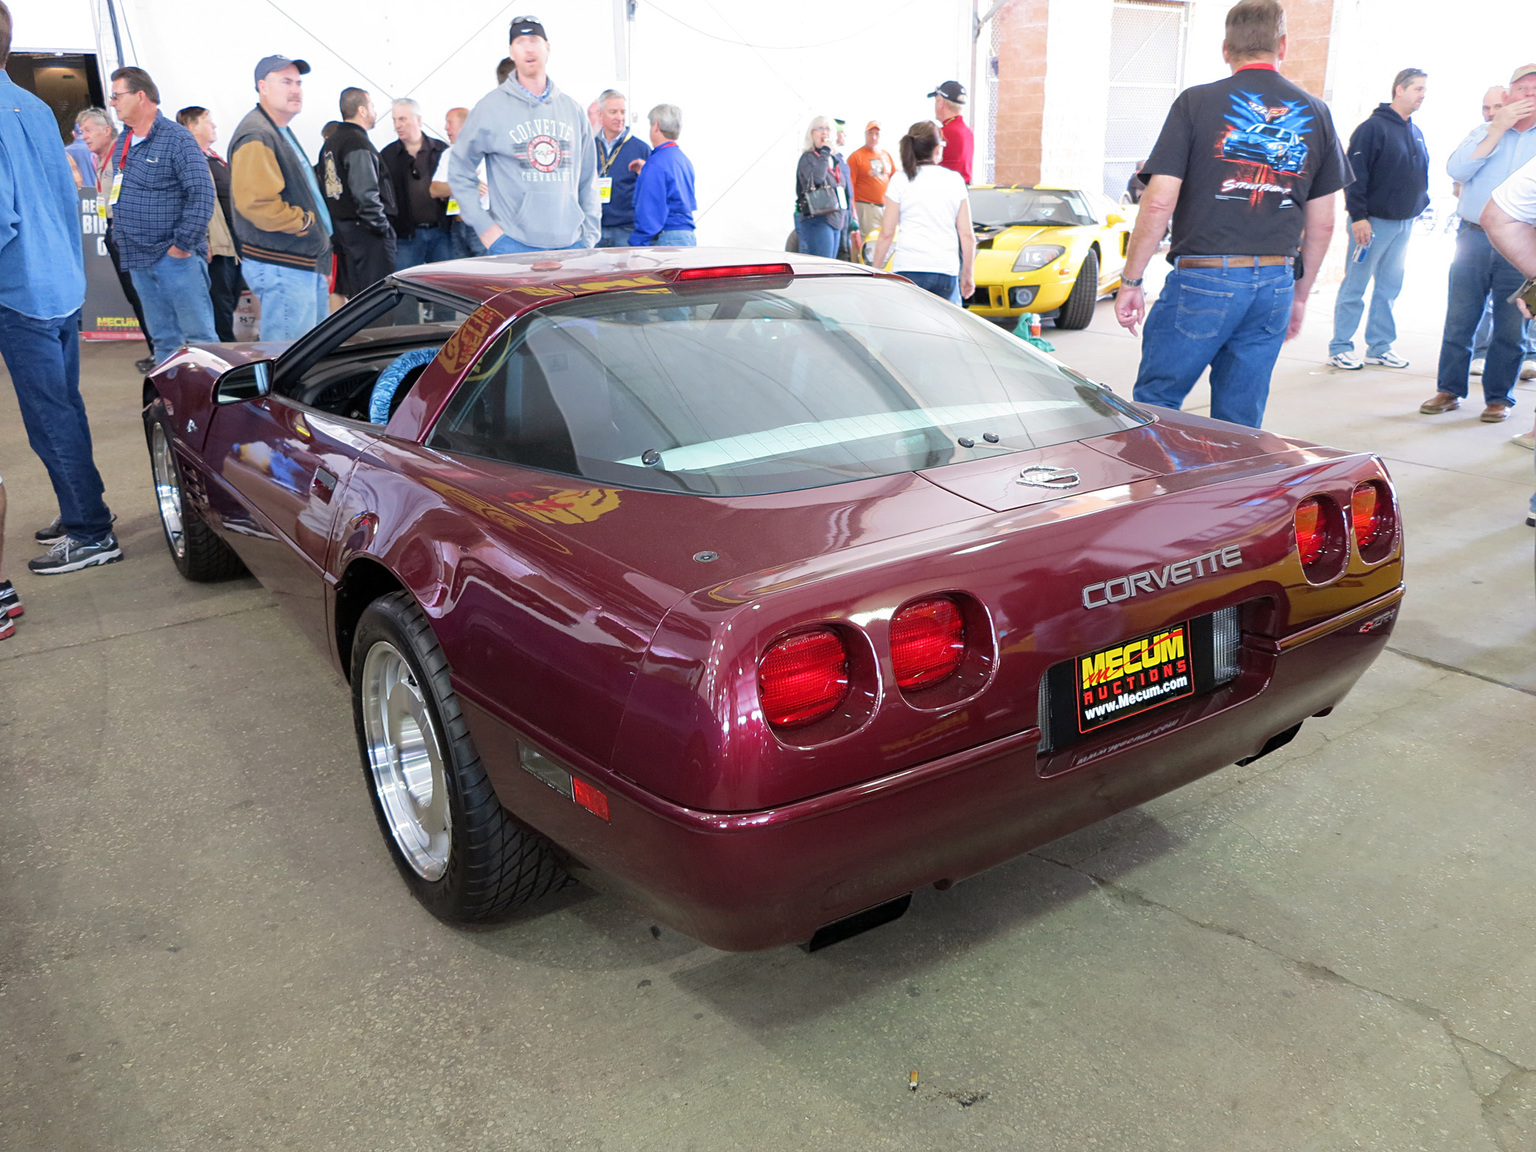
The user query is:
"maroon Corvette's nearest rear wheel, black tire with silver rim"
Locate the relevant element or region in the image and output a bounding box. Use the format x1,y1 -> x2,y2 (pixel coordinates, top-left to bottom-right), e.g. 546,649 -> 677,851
352,591 -> 568,923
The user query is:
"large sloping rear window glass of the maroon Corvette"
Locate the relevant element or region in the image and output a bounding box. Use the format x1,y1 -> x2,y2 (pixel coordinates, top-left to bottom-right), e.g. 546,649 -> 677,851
429,276 -> 1147,496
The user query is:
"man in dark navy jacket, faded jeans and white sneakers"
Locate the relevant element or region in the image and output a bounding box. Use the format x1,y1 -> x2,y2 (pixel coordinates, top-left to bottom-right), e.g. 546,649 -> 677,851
1329,68 -> 1430,372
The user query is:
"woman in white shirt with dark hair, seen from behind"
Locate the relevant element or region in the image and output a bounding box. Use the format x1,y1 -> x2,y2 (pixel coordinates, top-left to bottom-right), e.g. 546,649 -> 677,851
874,120 -> 975,304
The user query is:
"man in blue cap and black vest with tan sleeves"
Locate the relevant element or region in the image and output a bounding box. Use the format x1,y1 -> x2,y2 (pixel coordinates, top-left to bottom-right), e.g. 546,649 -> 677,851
229,55 -> 332,339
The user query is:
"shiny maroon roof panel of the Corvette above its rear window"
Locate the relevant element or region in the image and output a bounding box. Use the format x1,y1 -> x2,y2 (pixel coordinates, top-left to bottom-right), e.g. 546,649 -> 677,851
395,247 -> 876,310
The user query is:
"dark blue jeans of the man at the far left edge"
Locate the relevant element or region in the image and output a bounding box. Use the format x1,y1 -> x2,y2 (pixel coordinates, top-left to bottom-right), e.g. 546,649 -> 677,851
0,304 -> 112,544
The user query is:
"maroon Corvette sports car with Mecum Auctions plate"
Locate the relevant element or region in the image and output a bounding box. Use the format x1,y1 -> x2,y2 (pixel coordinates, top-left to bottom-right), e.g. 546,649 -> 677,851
144,249 -> 1402,949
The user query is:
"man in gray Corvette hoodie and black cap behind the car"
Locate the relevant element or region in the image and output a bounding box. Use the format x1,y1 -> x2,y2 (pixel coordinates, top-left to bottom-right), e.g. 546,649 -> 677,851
449,17 -> 602,255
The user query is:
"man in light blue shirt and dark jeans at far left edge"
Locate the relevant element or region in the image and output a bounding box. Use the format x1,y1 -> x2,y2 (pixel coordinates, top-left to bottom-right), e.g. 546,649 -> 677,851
0,3 -> 119,576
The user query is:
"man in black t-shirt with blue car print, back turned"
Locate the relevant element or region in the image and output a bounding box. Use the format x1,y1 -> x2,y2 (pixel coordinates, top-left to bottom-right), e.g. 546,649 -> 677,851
1115,0 -> 1353,429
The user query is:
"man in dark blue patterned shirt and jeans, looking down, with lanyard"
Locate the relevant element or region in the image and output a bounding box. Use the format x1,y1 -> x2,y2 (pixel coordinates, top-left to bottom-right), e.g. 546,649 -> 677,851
111,68 -> 218,364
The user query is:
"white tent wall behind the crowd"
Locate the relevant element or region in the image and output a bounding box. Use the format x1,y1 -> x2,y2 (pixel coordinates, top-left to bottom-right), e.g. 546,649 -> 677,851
48,0 -> 980,249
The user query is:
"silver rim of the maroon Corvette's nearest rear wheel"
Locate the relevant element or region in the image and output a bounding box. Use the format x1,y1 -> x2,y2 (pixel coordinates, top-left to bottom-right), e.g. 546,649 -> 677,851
361,641 -> 452,880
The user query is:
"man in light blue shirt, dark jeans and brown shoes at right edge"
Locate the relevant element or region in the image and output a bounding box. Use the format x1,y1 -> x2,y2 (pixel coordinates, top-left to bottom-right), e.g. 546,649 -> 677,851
1419,65 -> 1536,424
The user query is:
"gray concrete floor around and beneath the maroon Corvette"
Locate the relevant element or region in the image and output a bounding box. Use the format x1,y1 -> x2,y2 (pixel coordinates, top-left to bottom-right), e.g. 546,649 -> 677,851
0,230 -> 1536,1152
